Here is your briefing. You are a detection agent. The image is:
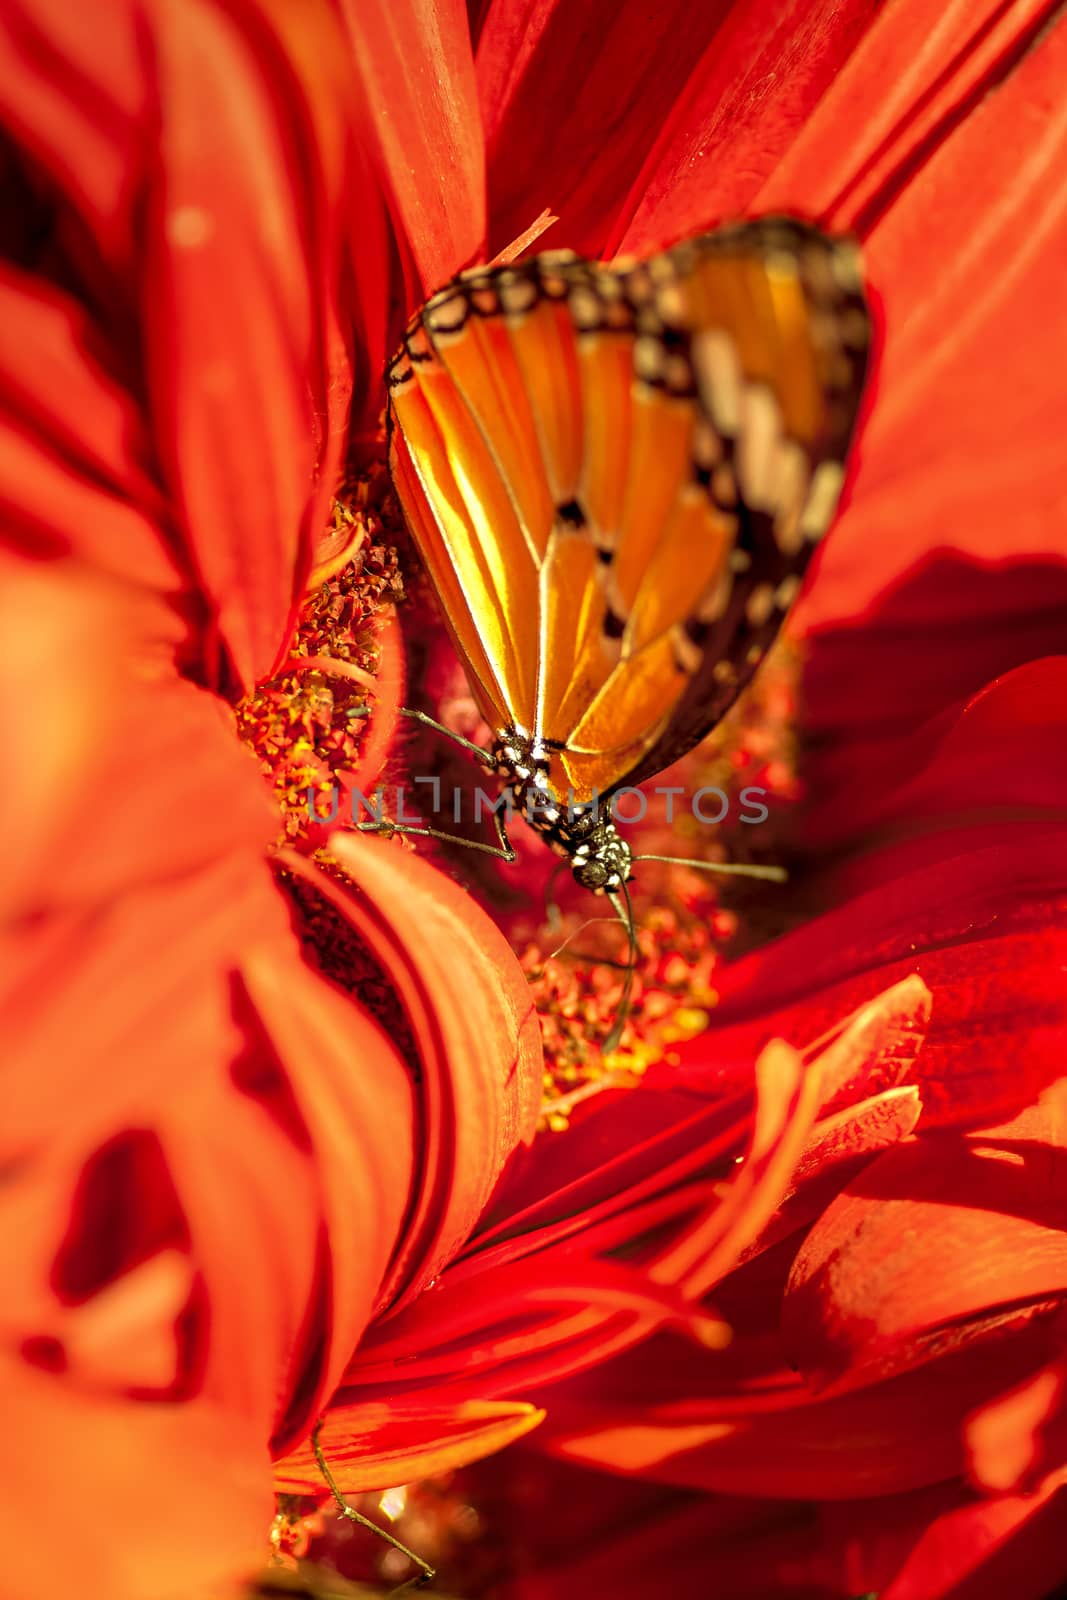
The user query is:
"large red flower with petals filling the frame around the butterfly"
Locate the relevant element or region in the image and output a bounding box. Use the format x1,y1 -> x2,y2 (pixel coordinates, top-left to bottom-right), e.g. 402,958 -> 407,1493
8,0 -> 1067,1600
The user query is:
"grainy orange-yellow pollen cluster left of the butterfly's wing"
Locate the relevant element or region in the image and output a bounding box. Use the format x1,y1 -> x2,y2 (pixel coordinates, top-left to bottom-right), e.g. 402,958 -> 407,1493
235,470 -> 403,843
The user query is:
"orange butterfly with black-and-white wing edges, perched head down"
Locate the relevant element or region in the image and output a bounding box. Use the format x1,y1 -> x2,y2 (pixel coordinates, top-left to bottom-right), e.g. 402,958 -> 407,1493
387,216 -> 870,902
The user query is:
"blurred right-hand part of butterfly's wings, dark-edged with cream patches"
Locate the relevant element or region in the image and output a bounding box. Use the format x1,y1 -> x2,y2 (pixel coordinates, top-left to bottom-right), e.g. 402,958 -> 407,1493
601,218 -> 870,800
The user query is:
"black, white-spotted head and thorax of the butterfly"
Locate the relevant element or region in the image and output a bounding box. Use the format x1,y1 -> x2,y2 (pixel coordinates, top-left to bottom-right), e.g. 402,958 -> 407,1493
491,728 -> 632,894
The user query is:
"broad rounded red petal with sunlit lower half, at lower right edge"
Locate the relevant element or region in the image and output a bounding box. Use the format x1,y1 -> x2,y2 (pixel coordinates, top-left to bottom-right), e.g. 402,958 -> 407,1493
784,1109 -> 1067,1384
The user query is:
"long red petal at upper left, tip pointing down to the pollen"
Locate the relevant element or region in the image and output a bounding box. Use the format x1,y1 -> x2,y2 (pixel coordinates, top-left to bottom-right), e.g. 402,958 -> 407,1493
142,6 -> 350,686
